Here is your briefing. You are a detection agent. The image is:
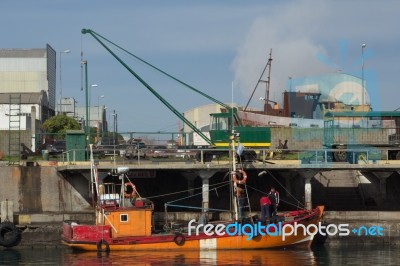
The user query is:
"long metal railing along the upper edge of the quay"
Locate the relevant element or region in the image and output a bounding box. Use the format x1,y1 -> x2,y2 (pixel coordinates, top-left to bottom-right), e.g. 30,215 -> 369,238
42,148 -> 400,164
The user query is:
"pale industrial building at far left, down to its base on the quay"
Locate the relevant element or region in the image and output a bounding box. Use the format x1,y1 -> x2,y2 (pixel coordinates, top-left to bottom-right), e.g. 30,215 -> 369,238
0,44 -> 56,159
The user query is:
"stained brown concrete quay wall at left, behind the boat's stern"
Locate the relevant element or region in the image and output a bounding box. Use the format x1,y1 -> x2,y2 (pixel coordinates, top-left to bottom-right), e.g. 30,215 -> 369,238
0,166 -> 91,217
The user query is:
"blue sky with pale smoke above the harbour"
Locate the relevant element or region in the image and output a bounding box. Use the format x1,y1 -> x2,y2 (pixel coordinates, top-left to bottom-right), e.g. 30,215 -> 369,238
0,0 -> 400,132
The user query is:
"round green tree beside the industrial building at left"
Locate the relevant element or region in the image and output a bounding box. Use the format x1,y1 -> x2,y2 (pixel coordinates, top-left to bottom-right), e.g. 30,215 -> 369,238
41,114 -> 81,139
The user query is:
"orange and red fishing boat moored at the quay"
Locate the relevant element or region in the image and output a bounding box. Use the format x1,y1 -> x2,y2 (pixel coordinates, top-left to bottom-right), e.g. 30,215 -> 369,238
62,133 -> 324,252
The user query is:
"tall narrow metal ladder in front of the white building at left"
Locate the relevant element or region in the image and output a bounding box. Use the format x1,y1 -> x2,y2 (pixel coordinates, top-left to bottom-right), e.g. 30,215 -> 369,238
8,94 -> 21,165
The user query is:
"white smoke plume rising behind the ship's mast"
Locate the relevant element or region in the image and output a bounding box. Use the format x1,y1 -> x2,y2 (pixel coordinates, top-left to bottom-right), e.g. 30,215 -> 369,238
232,1 -> 332,106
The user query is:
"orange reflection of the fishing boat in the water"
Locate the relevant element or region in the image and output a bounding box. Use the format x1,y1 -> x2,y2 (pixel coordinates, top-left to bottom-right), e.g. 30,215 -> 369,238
63,250 -> 316,266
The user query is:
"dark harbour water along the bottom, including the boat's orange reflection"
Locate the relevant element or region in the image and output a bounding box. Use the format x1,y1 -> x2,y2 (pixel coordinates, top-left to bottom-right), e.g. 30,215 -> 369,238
0,245 -> 400,266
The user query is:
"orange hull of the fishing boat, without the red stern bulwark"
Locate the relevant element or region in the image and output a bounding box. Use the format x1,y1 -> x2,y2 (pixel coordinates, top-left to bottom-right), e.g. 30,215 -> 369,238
63,206 -> 324,251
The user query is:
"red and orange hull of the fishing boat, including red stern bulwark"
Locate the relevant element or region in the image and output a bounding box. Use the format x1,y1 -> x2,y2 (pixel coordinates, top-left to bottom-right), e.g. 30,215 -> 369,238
63,207 -> 323,252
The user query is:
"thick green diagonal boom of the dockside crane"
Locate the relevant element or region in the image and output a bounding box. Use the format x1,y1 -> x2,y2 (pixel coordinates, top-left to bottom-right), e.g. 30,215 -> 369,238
81,29 -> 214,145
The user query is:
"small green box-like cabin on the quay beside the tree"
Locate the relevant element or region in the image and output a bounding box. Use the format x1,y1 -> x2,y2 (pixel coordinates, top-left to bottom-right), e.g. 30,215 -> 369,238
65,130 -> 86,161
